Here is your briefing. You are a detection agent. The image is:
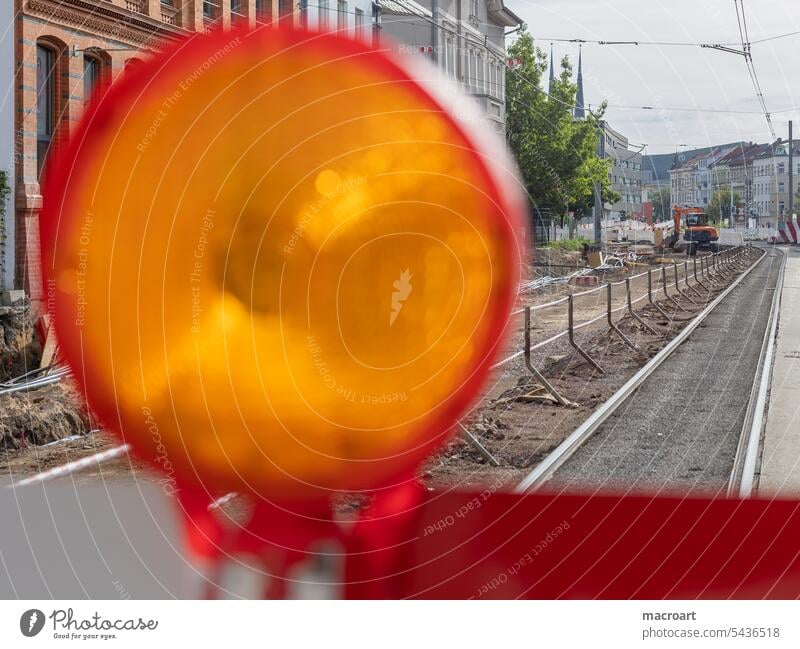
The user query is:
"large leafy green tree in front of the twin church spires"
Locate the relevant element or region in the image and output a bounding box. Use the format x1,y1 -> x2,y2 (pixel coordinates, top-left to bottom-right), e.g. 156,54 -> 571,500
506,28 -> 619,228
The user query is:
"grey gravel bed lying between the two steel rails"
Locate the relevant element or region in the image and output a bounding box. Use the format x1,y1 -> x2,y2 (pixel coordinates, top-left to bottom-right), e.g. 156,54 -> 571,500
547,250 -> 782,494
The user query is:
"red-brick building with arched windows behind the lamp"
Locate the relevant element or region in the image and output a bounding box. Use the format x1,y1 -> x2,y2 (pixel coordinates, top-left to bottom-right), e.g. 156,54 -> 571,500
0,0 -> 378,301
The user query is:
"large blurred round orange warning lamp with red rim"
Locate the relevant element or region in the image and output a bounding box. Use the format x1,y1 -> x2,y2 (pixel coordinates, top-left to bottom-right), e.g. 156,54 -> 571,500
43,29 -> 523,499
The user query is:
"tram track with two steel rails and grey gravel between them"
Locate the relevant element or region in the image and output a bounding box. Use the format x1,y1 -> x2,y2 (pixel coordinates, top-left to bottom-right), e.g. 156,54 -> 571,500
516,248 -> 785,497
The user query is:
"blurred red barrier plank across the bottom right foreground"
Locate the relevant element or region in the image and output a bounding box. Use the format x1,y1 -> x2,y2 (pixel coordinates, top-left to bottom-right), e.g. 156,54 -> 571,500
346,491 -> 800,599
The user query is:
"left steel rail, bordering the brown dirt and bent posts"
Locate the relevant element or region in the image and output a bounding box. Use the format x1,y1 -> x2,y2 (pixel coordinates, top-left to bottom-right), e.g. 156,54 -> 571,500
514,247 -> 766,493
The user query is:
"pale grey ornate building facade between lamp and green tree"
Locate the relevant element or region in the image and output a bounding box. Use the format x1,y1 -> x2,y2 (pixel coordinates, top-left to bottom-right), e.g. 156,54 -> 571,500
378,0 -> 522,134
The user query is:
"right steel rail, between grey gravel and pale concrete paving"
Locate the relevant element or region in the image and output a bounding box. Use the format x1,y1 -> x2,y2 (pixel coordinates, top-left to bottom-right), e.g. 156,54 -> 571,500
728,251 -> 786,498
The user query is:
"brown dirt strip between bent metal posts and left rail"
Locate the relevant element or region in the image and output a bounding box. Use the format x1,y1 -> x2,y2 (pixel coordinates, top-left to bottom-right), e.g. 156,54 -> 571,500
423,248 -> 766,490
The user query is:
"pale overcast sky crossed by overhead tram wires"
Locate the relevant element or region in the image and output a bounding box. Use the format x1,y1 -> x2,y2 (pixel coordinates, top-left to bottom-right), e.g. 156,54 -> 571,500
516,0 -> 800,154
